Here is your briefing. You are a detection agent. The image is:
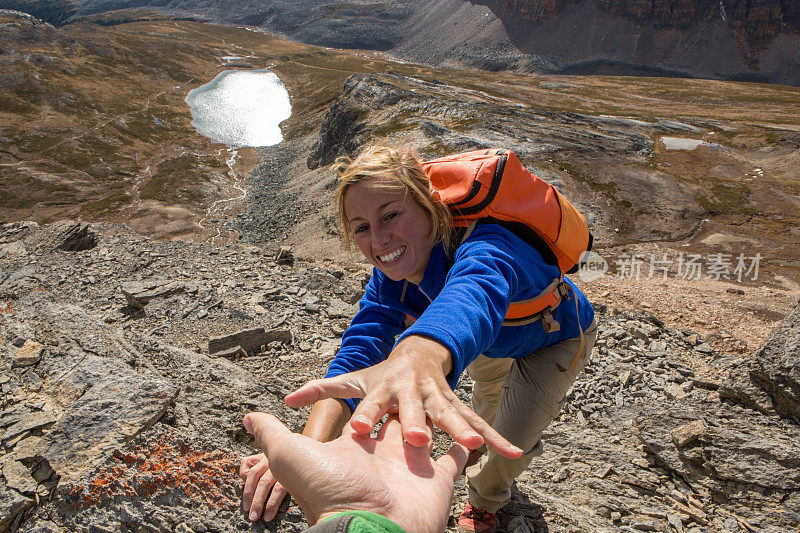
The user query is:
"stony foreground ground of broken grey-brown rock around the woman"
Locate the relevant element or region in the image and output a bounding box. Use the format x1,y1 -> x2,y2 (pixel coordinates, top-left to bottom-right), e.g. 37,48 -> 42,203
0,221 -> 800,532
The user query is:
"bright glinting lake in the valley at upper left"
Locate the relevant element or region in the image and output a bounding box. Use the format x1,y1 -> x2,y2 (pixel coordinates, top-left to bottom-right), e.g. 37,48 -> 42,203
186,70 -> 292,148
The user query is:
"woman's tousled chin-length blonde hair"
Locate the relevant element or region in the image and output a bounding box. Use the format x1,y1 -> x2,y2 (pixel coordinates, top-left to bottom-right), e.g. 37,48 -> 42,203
336,145 -> 453,251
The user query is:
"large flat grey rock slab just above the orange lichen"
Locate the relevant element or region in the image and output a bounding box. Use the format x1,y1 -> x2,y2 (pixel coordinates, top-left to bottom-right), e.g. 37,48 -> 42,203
38,373 -> 179,482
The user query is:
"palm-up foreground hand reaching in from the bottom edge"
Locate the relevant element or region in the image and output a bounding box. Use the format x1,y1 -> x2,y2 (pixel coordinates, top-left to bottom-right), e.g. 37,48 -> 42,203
244,413 -> 467,532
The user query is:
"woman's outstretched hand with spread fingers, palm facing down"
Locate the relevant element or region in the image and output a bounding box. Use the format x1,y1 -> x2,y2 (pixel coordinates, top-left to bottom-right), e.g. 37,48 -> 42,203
286,335 -> 522,459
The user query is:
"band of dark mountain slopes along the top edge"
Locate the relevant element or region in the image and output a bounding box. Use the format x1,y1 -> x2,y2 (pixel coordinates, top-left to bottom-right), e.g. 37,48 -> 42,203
64,0 -> 800,85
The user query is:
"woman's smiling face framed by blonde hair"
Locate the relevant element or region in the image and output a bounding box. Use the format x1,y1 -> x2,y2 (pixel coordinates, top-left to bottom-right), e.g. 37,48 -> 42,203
344,180 -> 433,284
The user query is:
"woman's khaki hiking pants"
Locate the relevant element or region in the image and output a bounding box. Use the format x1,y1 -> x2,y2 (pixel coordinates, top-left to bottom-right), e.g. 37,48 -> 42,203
467,322 -> 597,513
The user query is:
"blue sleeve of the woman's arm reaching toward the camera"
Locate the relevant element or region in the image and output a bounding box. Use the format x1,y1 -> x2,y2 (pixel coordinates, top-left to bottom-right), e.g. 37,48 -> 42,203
398,225 -> 558,388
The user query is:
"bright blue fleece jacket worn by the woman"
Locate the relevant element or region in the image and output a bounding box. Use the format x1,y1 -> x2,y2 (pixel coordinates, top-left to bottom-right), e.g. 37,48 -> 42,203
325,224 -> 594,409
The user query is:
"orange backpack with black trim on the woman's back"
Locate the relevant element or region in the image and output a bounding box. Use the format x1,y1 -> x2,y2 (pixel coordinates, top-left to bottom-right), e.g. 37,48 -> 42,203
422,150 -> 593,331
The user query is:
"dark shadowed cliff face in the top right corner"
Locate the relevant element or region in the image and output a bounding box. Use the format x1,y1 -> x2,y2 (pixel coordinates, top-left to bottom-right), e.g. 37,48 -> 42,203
484,0 -> 800,85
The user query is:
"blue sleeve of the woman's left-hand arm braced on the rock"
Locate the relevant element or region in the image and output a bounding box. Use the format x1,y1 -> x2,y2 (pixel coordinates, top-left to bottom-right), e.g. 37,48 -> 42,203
325,270 -> 405,411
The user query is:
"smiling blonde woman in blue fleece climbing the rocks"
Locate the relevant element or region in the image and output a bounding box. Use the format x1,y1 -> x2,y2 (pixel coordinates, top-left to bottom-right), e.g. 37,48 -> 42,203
241,146 -> 597,533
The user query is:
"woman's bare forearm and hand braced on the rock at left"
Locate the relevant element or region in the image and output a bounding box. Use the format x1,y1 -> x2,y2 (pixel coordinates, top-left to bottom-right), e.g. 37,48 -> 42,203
239,399 -> 350,522
